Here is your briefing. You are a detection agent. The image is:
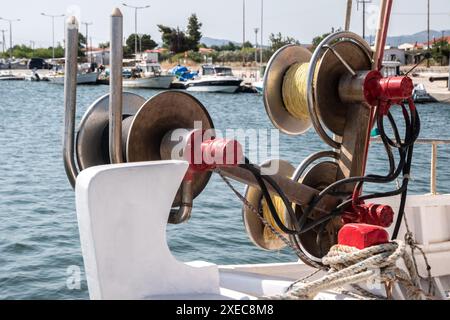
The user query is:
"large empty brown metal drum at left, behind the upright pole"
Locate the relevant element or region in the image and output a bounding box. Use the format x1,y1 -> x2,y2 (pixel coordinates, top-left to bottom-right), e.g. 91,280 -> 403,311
76,91 -> 214,207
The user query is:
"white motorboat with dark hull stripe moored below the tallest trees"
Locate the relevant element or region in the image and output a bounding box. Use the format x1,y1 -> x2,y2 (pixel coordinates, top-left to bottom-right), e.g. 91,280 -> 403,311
186,65 -> 243,93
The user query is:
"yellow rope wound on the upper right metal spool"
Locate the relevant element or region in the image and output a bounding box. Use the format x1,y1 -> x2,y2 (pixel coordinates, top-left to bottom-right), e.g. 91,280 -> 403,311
282,63 -> 309,120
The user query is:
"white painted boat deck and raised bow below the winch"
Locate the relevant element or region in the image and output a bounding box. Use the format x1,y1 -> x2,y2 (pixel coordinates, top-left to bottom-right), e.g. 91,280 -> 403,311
76,161 -> 450,300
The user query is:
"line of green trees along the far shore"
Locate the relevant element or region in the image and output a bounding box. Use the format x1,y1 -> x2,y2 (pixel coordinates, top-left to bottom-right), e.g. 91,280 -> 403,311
2,13 -> 449,64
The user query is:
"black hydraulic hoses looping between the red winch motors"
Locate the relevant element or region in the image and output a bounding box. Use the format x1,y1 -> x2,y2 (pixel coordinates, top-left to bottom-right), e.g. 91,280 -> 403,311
236,100 -> 420,249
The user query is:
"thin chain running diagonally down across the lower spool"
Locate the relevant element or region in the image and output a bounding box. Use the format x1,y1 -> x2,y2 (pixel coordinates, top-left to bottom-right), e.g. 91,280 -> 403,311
215,170 -> 325,270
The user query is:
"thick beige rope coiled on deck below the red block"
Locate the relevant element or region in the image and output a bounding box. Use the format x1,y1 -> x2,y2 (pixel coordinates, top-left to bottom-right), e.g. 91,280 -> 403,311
268,241 -> 434,300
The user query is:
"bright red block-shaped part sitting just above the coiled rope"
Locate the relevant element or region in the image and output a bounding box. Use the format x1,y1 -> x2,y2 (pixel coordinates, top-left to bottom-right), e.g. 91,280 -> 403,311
338,224 -> 389,250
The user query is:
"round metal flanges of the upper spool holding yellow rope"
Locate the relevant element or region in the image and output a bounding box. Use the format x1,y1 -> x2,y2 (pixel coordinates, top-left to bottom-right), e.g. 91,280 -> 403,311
264,32 -> 372,149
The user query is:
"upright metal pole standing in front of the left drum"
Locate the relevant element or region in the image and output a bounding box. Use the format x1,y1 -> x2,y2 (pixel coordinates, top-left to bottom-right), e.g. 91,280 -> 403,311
109,8 -> 123,163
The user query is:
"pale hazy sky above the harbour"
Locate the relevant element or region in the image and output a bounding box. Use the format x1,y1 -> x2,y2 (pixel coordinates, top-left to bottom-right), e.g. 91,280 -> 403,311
0,0 -> 450,46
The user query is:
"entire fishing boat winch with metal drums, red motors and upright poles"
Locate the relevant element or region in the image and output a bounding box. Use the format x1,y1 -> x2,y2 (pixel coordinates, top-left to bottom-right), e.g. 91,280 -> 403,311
64,5 -> 420,268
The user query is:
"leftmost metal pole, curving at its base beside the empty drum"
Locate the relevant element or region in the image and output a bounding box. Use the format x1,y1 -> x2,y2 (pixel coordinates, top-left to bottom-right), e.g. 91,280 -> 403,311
63,17 -> 78,187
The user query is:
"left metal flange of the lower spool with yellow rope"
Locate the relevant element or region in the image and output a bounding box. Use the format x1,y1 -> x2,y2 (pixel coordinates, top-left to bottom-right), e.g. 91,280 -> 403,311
242,160 -> 295,251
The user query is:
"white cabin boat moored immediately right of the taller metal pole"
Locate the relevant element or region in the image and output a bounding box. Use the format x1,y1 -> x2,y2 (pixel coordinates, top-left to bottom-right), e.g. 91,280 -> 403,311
123,62 -> 175,89
